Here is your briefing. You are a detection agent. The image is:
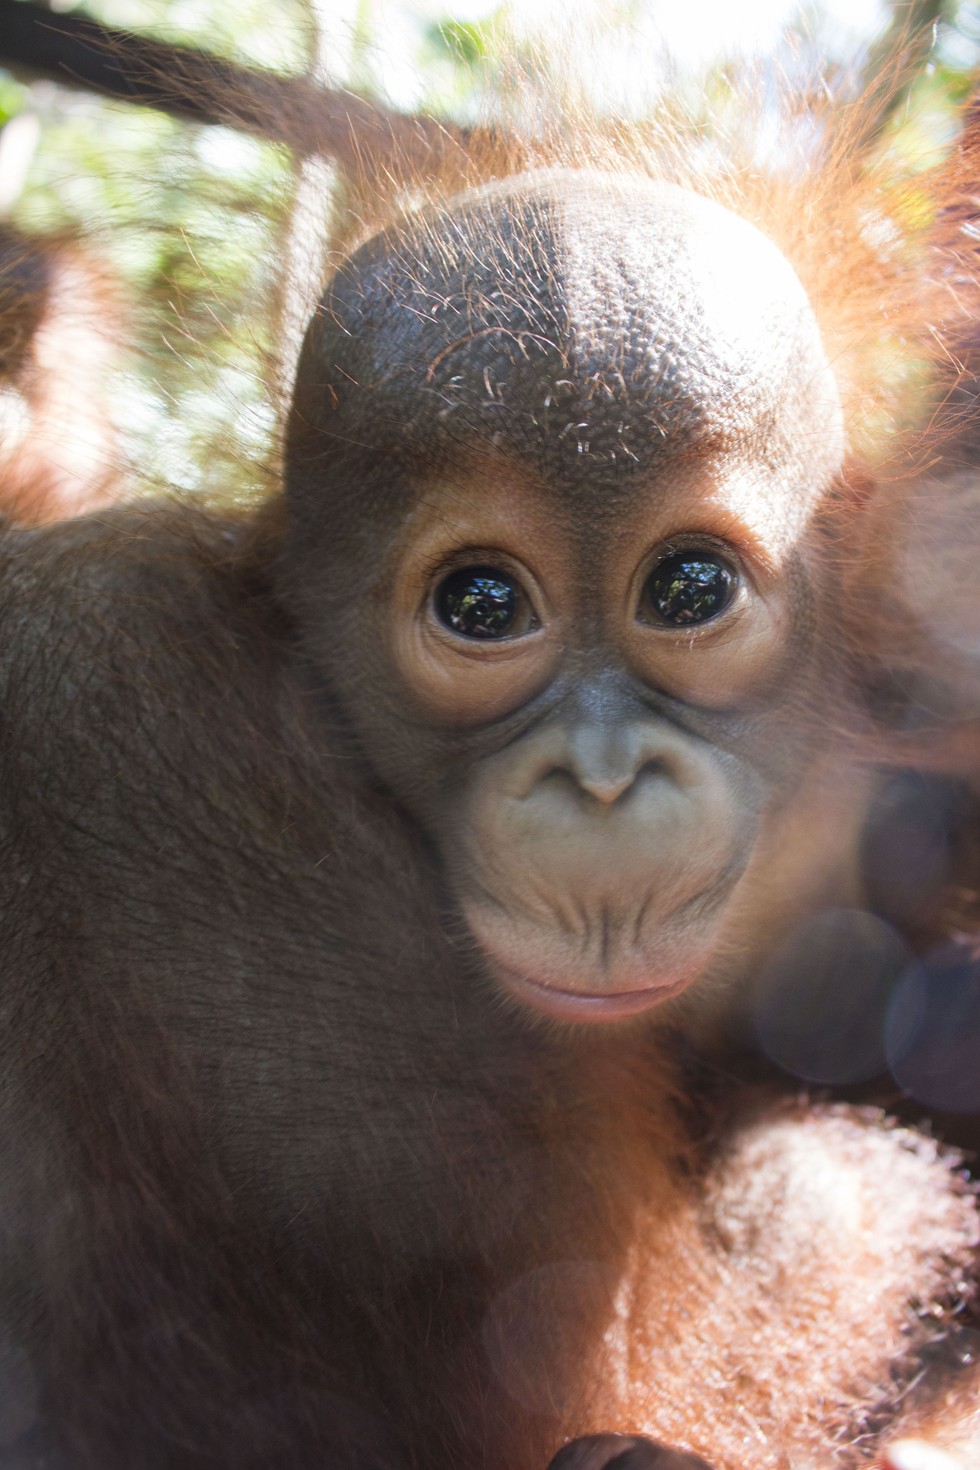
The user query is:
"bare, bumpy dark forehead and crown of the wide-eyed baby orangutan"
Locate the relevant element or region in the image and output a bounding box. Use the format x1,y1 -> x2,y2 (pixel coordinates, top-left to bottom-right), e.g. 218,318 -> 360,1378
318,172 -> 840,485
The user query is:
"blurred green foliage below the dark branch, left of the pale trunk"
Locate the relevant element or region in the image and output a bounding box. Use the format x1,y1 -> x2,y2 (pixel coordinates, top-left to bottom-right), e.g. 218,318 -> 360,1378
16,96 -> 292,497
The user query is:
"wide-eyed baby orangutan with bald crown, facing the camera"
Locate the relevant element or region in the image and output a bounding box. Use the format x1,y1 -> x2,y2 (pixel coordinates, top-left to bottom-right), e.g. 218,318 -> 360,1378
0,103 -> 980,1470
